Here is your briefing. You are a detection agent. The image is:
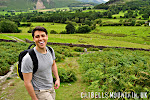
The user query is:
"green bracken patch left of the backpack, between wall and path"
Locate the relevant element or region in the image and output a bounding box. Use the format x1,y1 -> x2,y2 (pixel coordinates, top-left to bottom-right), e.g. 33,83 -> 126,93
0,42 -> 27,76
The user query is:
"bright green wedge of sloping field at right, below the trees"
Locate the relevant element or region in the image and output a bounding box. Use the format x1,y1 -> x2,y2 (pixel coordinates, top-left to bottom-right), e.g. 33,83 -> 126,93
91,26 -> 150,45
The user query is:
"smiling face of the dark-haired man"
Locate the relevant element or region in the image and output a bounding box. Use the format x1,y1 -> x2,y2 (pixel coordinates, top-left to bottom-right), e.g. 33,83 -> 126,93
33,31 -> 48,49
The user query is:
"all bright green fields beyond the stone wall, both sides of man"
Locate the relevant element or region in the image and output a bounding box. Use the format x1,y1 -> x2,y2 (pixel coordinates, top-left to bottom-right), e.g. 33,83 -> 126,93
0,22 -> 150,49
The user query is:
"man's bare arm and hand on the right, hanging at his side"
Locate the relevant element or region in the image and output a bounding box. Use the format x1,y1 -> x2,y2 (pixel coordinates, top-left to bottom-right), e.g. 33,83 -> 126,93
52,60 -> 60,89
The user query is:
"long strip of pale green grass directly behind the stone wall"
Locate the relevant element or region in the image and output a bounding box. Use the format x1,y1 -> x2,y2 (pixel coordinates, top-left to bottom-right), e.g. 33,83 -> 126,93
0,33 -> 150,49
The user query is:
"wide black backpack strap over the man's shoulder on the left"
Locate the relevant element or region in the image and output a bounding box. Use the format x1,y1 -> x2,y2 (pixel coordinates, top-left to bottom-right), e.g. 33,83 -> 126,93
29,48 -> 38,74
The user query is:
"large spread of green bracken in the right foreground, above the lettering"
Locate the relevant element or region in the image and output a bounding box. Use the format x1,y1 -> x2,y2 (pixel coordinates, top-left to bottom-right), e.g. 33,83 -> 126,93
79,48 -> 150,95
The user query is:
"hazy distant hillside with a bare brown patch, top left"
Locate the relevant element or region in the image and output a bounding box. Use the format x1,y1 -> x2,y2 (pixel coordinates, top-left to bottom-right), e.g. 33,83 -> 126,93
0,0 -> 104,10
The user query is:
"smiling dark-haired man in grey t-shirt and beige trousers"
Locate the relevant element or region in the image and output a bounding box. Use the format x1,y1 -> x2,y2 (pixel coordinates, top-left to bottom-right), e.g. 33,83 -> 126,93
21,26 -> 60,100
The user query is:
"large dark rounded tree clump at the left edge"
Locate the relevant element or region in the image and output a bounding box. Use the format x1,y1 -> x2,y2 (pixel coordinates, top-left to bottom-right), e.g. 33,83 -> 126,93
0,20 -> 20,33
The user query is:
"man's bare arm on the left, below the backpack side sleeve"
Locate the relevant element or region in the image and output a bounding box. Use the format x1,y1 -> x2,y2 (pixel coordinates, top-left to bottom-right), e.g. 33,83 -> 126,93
23,73 -> 38,100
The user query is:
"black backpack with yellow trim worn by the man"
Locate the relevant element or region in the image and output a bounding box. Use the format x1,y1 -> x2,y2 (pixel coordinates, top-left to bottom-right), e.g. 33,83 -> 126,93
17,43 -> 53,80
